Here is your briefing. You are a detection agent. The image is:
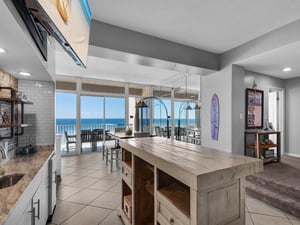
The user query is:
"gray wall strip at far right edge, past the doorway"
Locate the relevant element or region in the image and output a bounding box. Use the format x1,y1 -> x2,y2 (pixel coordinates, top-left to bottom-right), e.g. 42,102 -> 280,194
285,78 -> 300,157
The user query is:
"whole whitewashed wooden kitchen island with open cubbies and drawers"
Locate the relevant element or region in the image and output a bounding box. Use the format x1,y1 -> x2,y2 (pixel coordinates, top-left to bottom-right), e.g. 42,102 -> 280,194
120,137 -> 263,225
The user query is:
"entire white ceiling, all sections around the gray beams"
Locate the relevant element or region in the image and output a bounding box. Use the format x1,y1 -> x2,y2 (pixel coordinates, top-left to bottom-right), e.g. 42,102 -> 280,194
0,0 -> 300,85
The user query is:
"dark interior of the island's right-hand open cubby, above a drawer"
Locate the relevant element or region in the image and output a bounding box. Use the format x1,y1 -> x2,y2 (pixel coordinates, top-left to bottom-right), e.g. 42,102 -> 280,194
158,181 -> 190,217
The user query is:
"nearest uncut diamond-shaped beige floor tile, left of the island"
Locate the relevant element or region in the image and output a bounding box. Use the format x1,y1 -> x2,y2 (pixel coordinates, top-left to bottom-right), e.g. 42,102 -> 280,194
65,189 -> 104,205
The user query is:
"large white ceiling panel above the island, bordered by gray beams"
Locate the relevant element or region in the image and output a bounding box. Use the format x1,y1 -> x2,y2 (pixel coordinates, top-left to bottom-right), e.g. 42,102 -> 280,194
89,0 -> 300,53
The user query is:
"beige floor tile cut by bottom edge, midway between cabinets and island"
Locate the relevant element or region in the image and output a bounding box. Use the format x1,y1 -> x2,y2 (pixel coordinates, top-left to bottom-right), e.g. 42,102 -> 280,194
63,206 -> 111,225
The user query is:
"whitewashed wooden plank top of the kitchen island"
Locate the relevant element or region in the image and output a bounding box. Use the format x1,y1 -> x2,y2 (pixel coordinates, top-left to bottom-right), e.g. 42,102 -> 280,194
120,137 -> 263,191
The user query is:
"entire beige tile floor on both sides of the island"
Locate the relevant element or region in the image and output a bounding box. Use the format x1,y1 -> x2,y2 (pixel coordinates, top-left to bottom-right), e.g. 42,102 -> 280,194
48,152 -> 300,225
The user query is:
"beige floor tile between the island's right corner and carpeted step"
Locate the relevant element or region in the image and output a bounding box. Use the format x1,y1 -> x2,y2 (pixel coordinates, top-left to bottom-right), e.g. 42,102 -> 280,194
246,197 -> 286,218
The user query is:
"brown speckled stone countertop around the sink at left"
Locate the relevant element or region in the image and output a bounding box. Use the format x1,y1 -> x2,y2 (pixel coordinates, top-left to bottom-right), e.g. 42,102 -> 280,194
0,145 -> 54,224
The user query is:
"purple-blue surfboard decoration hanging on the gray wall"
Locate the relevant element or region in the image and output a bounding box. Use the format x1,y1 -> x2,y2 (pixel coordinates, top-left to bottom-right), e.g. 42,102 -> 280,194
210,94 -> 220,141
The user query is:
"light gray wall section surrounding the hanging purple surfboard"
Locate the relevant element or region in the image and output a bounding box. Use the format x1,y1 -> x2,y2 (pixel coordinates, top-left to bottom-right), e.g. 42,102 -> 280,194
201,66 -> 232,152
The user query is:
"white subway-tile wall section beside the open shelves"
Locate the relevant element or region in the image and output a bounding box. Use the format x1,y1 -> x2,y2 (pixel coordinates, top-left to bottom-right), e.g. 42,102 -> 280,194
19,80 -> 55,146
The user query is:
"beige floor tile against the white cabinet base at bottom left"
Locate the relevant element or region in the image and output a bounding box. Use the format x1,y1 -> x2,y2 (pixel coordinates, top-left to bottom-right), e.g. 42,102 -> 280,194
51,202 -> 84,224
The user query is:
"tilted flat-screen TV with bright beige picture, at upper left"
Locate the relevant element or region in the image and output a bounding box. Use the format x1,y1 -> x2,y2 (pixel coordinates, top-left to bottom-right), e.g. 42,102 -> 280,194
13,0 -> 91,67
